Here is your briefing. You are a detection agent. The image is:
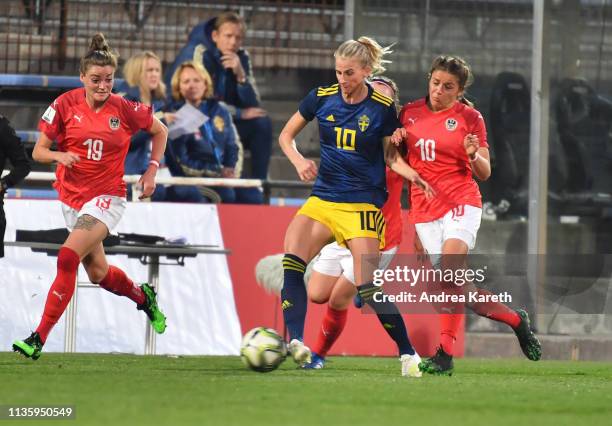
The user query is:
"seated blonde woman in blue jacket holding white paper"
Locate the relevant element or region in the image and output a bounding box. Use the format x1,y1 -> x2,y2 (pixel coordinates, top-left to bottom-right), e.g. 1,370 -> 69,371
166,61 -> 239,203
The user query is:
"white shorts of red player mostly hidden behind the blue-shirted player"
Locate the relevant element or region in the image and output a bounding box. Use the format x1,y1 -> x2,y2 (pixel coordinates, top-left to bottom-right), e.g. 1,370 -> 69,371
312,242 -> 397,284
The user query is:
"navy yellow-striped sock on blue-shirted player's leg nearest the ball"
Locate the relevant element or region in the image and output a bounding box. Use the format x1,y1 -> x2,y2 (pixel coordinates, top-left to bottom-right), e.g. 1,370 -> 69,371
281,253 -> 308,340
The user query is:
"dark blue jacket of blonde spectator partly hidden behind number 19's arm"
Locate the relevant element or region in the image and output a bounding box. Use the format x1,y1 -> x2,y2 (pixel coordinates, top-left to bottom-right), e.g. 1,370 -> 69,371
116,81 -> 166,175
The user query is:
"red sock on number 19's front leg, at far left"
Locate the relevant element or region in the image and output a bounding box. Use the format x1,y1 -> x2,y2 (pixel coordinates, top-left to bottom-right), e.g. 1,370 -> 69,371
36,247 -> 81,343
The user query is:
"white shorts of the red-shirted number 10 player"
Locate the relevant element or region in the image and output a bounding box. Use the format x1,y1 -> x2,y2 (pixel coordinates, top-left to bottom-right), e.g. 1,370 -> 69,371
414,205 -> 482,265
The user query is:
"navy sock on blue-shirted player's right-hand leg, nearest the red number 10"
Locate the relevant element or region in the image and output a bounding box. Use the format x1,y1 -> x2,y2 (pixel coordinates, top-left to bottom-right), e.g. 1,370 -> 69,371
357,283 -> 415,355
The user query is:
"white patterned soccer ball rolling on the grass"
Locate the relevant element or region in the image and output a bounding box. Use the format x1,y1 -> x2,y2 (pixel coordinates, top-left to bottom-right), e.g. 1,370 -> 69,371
240,327 -> 287,373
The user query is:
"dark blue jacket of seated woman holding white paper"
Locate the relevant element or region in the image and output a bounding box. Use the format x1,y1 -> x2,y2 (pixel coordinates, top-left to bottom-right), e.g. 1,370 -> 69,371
165,99 -> 238,177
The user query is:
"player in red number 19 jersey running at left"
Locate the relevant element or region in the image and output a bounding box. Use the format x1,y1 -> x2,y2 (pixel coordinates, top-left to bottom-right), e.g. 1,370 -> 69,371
13,34 -> 168,360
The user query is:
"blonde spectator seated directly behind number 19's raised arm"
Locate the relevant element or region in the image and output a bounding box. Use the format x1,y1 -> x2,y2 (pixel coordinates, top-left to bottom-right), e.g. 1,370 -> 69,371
117,51 -> 174,201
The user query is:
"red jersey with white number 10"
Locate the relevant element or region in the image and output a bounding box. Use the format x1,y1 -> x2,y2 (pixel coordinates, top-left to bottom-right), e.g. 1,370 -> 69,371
400,98 -> 489,223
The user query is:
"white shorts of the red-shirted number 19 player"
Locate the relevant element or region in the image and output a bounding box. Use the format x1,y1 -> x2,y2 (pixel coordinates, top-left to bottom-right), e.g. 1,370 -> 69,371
62,195 -> 127,232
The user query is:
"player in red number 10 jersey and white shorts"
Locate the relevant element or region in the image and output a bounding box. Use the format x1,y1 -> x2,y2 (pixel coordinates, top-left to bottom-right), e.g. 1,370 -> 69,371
391,56 -> 542,375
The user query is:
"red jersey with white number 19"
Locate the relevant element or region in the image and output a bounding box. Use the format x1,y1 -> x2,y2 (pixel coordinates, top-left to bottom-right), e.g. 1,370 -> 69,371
38,88 -> 153,210
